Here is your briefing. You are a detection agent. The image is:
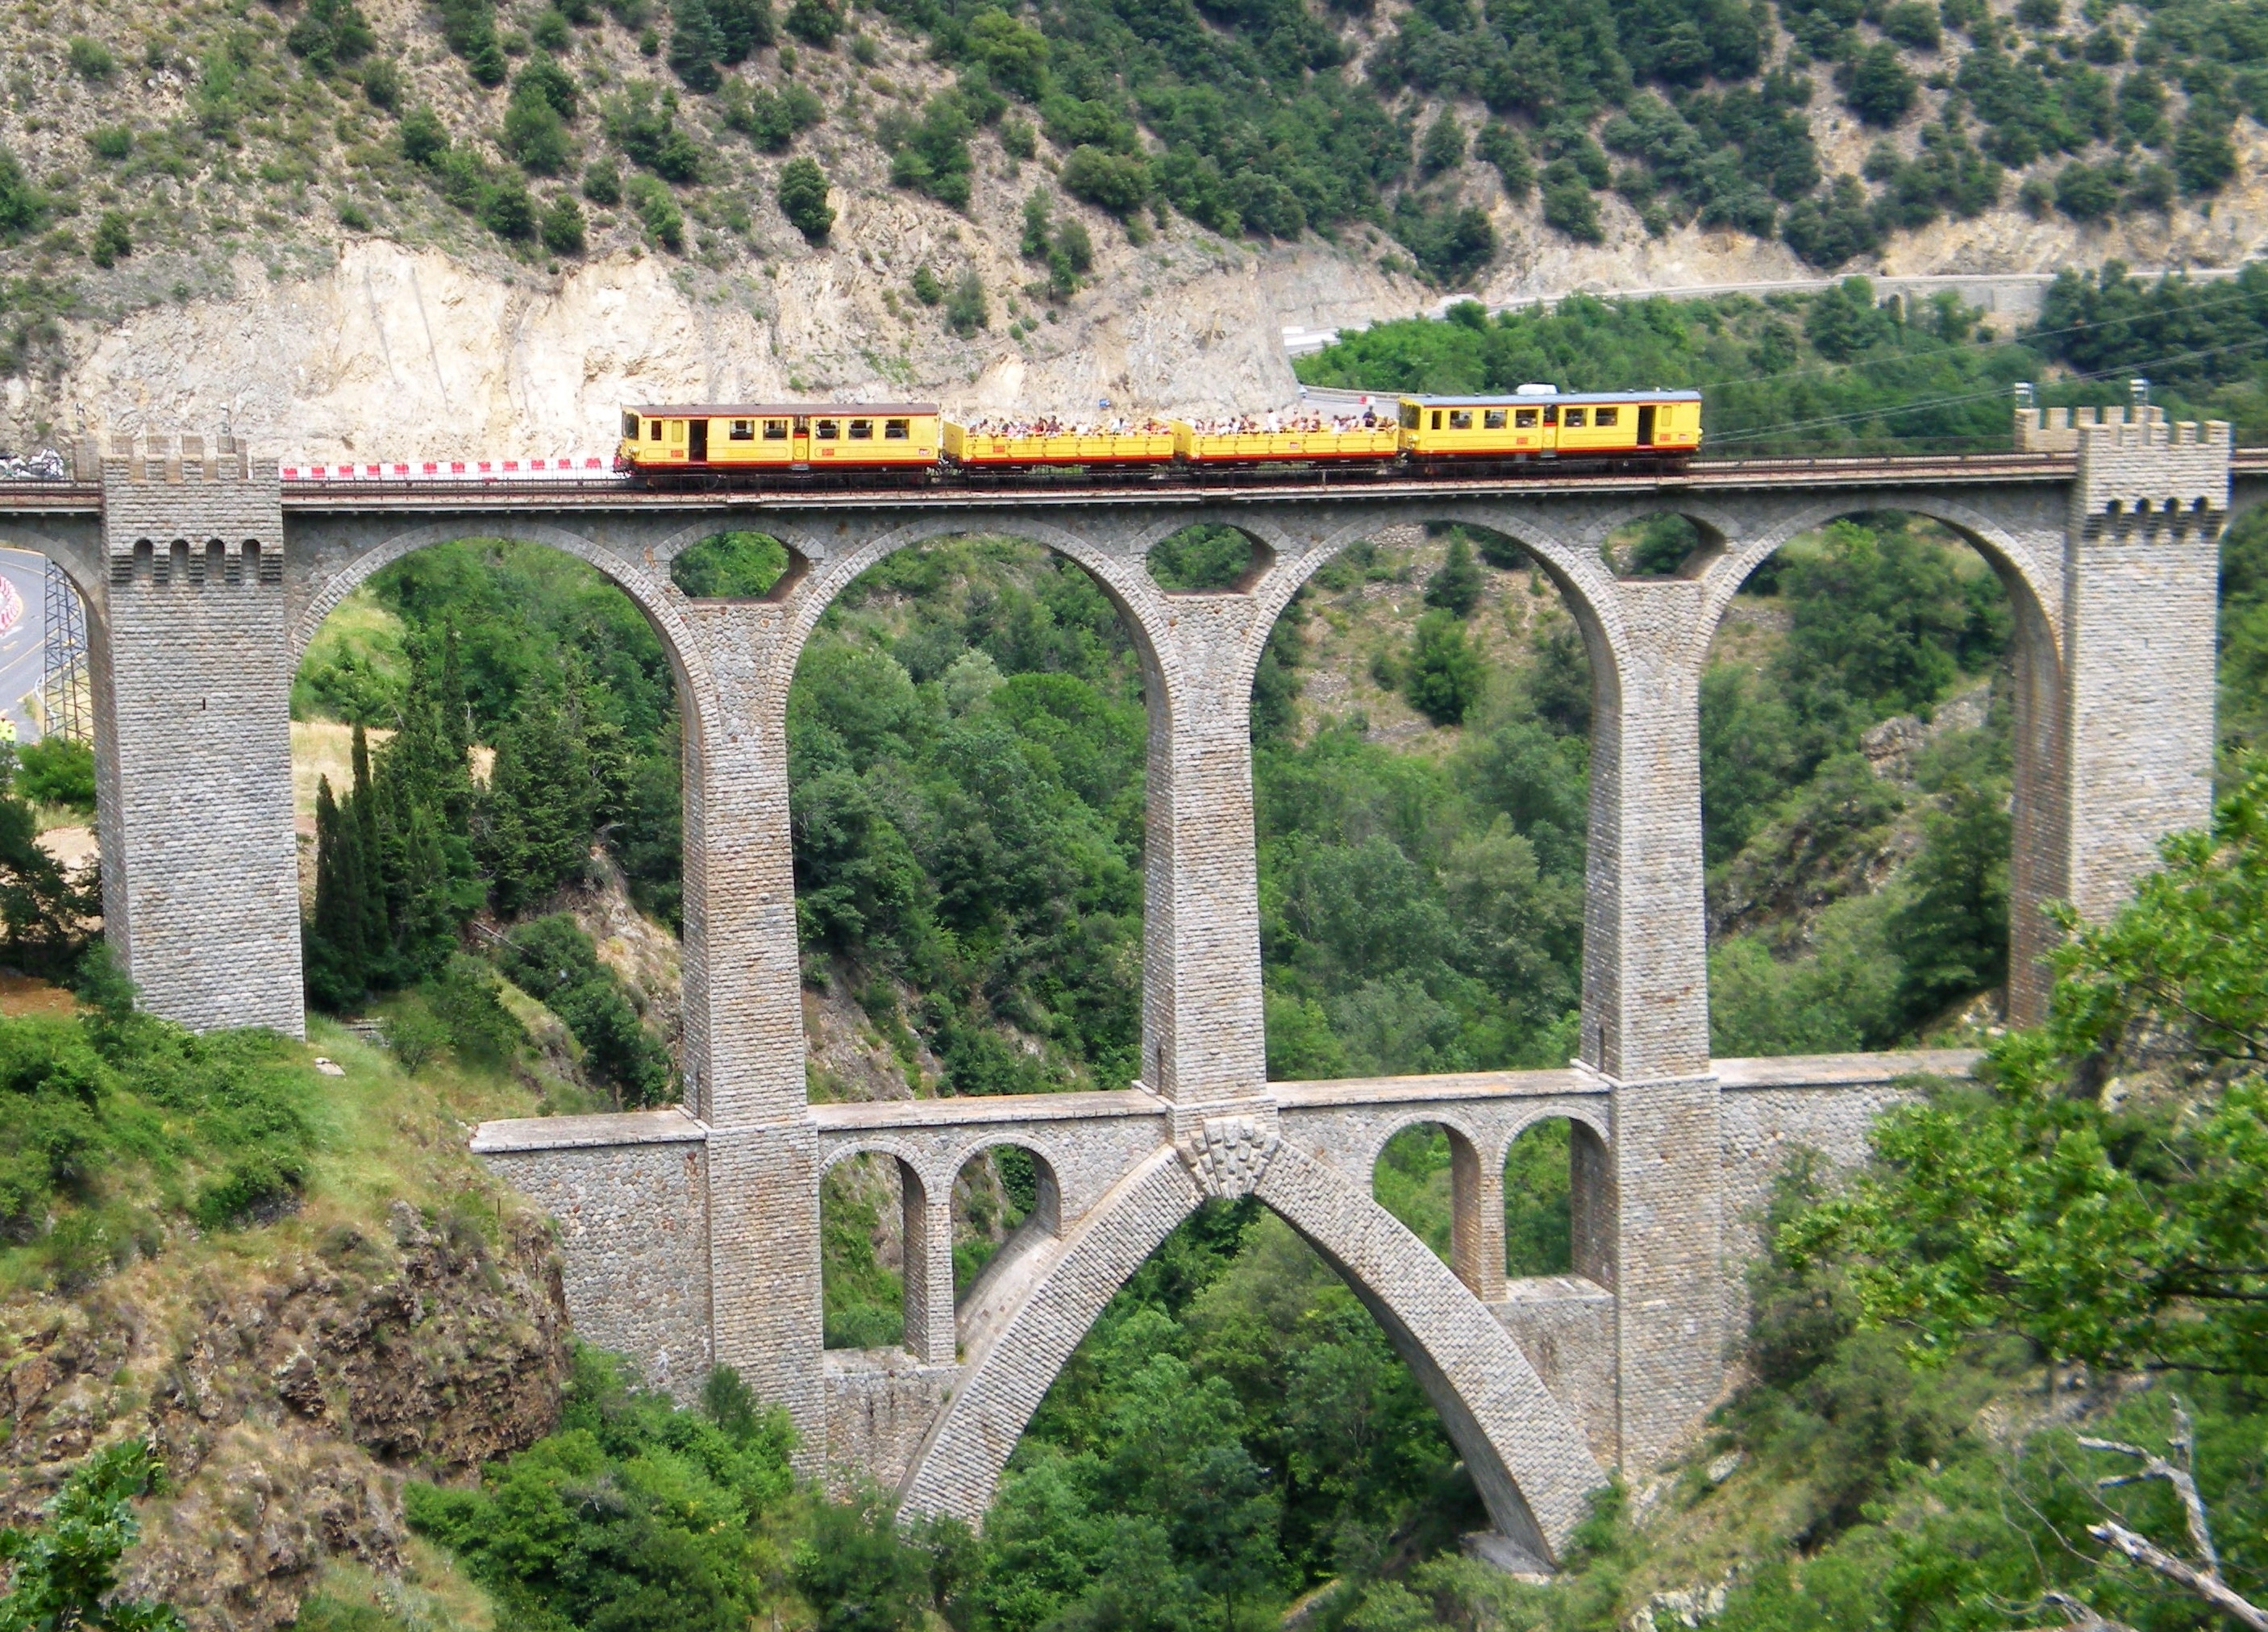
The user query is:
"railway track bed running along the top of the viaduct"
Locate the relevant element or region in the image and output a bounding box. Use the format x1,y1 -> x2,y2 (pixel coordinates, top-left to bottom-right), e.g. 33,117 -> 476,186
0,447 -> 2268,517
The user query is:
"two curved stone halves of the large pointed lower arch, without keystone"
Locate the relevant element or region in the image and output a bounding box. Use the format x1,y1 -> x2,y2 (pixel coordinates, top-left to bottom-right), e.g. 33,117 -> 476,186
898,1145 -> 1604,1559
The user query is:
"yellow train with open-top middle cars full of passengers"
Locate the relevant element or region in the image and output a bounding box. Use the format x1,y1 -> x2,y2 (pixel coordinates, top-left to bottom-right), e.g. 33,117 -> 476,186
614,385 -> 1701,485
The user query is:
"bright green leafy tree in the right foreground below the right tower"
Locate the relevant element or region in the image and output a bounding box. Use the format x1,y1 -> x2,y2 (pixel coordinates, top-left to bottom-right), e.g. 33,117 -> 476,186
1780,766 -> 2268,1376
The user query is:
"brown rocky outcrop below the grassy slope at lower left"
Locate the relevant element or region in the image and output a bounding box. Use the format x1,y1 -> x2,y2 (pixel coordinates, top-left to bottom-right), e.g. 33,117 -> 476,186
0,1201 -> 567,1632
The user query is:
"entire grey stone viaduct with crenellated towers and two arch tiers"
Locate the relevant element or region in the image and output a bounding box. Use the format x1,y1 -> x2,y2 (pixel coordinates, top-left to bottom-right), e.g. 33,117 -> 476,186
0,413 -> 2231,1559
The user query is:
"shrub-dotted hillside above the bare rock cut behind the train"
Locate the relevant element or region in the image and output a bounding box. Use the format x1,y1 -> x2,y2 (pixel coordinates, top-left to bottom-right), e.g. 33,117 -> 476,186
0,0 -> 2268,408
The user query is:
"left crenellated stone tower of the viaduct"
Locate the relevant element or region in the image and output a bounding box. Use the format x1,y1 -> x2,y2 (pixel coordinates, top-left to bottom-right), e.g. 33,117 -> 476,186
95,438 -> 306,1036
